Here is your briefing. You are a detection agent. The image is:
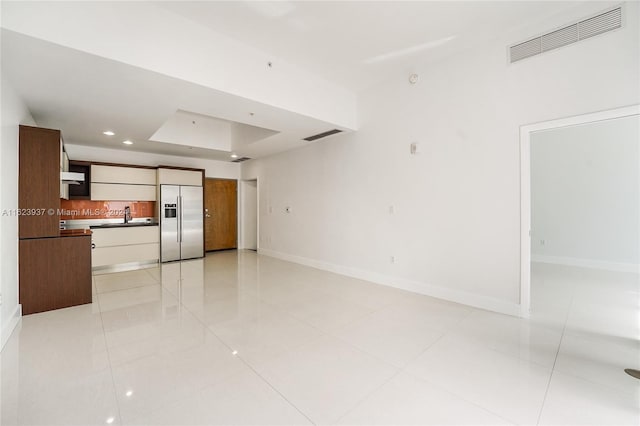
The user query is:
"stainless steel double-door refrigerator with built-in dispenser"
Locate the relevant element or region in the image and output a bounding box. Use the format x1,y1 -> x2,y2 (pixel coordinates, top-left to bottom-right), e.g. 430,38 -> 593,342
160,185 -> 204,262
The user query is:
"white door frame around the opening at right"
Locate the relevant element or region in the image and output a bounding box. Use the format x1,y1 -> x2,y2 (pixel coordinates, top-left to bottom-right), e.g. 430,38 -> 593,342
520,105 -> 640,318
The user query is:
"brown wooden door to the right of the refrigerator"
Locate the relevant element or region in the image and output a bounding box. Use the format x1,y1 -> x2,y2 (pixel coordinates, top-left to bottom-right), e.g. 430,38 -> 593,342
204,178 -> 238,251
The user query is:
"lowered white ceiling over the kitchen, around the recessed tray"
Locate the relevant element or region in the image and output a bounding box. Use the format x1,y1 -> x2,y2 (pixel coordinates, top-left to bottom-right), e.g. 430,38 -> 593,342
2,30 -> 340,161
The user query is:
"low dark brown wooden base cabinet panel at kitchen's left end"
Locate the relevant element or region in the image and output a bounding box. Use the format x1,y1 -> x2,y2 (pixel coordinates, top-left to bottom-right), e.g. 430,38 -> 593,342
19,235 -> 91,315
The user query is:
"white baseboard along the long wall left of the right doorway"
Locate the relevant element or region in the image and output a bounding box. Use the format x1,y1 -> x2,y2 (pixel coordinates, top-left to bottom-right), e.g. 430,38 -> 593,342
258,249 -> 525,316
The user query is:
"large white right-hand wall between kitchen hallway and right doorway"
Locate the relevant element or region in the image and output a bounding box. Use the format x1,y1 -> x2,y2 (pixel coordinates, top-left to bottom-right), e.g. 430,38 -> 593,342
243,3 -> 640,314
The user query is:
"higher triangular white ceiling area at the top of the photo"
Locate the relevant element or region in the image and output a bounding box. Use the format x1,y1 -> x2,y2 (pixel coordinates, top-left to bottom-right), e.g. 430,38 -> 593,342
156,1 -> 580,91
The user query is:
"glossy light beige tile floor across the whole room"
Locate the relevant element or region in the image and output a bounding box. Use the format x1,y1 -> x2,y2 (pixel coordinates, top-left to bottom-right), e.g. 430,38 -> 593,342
0,251 -> 640,425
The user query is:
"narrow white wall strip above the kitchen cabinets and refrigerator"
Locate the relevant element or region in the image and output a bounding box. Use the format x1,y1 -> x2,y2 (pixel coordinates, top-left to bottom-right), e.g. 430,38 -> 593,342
65,144 -> 240,179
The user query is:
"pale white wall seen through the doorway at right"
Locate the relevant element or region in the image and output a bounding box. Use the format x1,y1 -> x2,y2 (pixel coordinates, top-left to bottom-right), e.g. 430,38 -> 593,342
531,116 -> 640,270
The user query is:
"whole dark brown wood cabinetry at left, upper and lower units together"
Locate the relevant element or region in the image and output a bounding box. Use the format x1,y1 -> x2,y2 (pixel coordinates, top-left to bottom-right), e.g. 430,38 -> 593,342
18,126 -> 91,315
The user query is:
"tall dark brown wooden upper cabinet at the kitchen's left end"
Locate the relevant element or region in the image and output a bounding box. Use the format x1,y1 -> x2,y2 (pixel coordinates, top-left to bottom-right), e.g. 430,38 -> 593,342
18,126 -> 60,238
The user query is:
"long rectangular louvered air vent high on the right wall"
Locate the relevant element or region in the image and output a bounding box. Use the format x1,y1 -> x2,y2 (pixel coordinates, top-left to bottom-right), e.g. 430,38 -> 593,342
509,6 -> 622,63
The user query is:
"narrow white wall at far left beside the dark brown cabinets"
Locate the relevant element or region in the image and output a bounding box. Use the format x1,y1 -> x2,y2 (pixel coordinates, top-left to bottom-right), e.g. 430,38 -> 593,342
0,74 -> 35,348
